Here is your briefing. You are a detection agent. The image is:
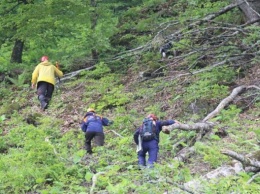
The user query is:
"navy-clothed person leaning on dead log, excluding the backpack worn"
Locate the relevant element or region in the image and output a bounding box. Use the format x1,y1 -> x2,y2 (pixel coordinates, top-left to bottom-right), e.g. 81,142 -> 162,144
134,114 -> 179,168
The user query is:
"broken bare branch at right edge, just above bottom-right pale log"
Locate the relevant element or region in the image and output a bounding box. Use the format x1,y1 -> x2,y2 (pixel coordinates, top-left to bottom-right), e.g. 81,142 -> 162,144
222,150 -> 260,170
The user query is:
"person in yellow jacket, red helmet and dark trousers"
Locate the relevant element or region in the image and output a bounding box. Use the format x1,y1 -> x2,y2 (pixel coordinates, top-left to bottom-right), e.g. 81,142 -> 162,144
32,56 -> 63,110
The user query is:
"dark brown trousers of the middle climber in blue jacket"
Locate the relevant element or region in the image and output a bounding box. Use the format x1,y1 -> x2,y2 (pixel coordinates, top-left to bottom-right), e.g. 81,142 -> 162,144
85,131 -> 105,153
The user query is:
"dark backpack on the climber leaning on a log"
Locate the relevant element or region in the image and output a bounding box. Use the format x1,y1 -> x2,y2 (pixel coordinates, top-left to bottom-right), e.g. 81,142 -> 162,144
139,118 -> 156,141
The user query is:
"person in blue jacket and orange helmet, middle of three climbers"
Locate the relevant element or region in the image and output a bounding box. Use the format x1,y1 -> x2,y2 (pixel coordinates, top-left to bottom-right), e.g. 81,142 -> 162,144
81,108 -> 113,154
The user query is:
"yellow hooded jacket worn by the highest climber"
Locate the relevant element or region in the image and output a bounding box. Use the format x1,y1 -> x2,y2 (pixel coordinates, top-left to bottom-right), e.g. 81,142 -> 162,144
32,61 -> 63,85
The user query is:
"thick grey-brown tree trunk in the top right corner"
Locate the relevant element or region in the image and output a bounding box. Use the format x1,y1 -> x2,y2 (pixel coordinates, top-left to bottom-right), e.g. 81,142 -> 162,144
235,0 -> 260,25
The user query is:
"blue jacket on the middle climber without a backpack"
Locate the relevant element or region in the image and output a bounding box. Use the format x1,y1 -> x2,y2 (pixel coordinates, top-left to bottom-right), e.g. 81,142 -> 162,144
81,112 -> 111,133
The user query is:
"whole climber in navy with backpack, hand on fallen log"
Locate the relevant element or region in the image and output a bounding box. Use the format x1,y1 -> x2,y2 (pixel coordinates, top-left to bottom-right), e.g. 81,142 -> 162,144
134,114 -> 179,169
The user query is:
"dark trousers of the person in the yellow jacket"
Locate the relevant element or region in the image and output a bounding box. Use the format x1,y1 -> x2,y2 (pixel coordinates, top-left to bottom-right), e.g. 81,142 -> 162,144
37,81 -> 54,103
